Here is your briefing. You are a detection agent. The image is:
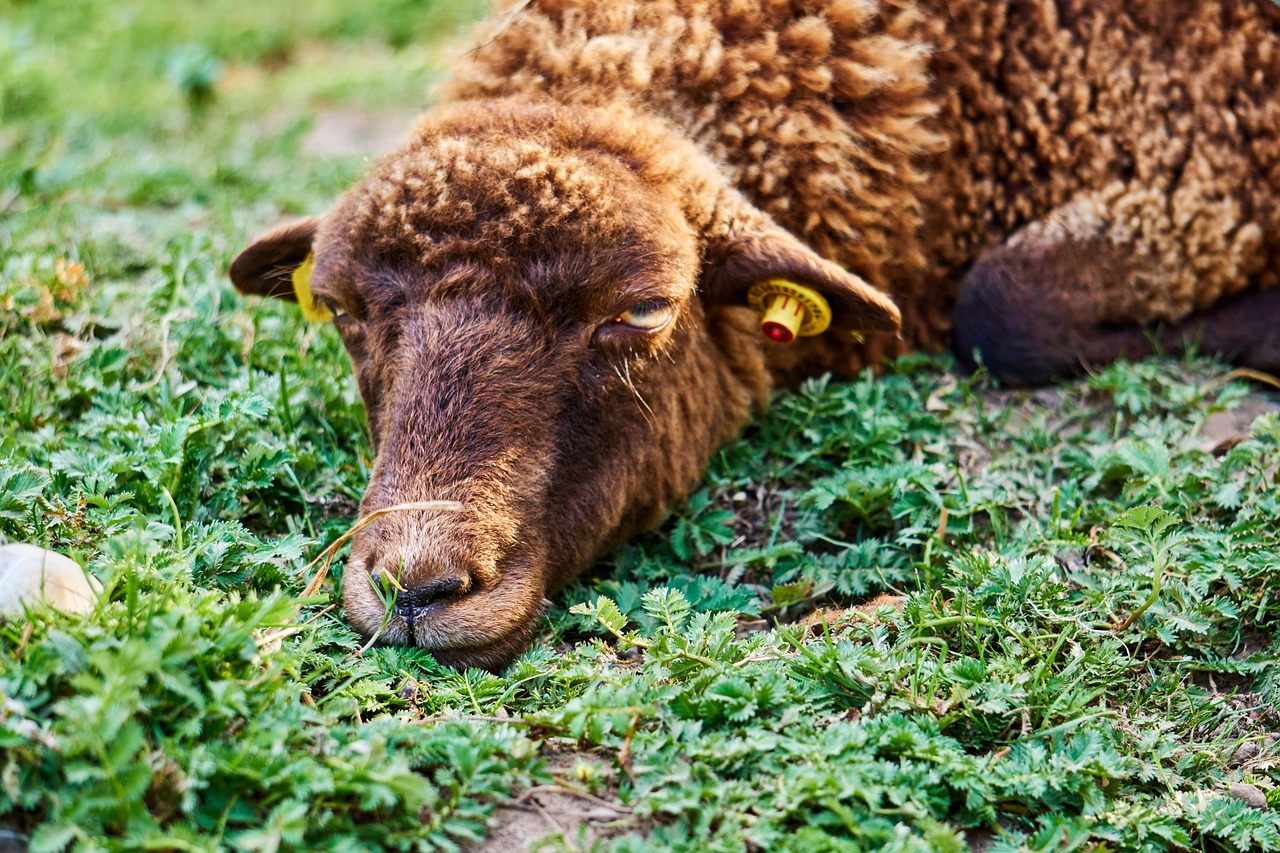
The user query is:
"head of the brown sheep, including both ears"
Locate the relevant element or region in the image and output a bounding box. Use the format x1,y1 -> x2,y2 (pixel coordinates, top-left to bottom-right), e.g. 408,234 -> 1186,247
232,103 -> 896,669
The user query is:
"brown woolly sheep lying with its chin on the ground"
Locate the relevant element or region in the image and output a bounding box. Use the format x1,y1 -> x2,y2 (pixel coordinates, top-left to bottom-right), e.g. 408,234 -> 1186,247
230,0 -> 1280,667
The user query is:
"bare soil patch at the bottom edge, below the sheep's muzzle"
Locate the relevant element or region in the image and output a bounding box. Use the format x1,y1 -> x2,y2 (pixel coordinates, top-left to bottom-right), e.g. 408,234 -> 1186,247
467,751 -> 644,853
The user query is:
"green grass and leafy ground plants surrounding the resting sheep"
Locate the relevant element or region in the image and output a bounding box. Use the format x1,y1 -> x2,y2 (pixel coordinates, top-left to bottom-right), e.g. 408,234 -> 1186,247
0,0 -> 1280,853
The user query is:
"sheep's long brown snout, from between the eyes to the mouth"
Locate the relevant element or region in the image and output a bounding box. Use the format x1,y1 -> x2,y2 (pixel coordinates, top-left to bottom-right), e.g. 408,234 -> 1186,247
344,298 -> 557,666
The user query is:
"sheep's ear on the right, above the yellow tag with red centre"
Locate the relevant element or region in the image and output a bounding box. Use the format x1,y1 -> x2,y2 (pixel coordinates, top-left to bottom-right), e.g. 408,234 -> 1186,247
703,225 -> 902,334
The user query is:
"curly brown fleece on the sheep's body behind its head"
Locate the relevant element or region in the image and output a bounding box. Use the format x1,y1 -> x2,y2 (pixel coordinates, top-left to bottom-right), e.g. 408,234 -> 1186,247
444,0 -> 1280,370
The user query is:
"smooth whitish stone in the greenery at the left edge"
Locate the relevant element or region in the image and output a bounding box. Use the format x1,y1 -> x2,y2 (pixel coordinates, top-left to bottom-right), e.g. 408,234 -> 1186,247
0,544 -> 102,619
